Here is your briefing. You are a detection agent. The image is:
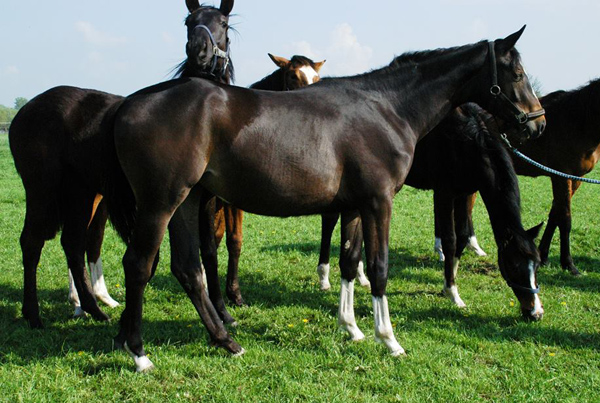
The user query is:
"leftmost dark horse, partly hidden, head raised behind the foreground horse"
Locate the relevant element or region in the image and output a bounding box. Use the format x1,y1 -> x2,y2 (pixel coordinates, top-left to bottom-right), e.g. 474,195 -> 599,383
9,0 -> 233,328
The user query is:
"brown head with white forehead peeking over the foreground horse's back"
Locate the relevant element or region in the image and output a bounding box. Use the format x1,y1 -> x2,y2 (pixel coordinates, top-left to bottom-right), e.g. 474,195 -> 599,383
269,53 -> 325,91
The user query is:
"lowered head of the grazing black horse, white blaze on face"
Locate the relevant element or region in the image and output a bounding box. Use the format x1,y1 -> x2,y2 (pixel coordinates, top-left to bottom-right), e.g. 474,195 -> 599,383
498,223 -> 544,320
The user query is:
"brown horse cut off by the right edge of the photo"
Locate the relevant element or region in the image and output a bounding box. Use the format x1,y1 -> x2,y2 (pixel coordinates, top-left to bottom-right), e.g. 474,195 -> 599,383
446,79 -> 600,276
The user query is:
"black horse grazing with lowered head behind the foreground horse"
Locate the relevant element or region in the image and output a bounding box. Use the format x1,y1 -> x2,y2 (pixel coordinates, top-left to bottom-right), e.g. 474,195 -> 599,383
318,104 -> 543,312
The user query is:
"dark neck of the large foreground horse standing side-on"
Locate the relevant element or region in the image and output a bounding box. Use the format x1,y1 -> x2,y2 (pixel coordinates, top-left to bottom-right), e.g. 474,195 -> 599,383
349,42 -> 491,139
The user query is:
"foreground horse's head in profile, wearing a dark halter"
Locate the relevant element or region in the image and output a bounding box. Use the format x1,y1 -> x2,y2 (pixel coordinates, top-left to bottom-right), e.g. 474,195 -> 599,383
478,26 -> 546,142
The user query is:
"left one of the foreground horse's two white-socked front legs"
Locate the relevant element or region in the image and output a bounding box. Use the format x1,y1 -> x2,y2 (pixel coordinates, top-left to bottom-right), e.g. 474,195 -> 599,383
338,212 -> 365,341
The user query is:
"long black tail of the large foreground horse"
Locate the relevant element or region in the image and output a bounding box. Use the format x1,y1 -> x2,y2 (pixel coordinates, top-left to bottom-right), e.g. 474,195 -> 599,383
102,101 -> 137,244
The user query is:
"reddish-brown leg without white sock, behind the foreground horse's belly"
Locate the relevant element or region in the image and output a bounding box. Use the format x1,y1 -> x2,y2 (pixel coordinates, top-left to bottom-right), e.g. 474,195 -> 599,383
224,204 -> 246,306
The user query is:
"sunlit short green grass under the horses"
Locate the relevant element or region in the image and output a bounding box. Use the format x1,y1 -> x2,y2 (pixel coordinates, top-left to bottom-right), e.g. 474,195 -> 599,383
0,135 -> 600,402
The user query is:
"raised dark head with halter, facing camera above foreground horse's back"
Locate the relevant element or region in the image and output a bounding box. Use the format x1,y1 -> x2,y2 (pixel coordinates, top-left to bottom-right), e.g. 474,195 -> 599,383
185,0 -> 233,81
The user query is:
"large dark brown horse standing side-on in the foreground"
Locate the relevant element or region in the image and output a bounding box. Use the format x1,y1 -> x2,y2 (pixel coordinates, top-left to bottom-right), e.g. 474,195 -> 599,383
105,27 -> 545,371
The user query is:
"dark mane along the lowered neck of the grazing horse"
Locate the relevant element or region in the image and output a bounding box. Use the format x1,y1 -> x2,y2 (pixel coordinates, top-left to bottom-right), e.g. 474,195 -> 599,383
452,103 -> 538,257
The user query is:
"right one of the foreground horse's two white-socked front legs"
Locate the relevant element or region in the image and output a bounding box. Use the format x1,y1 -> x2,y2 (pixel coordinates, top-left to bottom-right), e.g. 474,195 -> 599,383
361,197 -> 405,356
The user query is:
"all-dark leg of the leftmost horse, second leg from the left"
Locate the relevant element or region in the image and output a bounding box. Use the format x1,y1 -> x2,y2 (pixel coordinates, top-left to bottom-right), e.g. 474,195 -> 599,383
60,189 -> 109,320
